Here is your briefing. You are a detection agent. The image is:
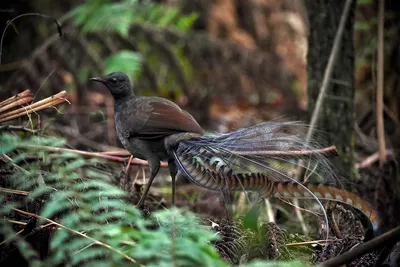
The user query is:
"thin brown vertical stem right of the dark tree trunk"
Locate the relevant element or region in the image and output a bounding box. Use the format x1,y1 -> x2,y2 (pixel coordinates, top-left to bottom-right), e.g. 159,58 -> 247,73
376,0 -> 386,167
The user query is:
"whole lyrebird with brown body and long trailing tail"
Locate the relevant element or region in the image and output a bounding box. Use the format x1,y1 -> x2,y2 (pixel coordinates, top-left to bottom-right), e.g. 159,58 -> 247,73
91,72 -> 376,232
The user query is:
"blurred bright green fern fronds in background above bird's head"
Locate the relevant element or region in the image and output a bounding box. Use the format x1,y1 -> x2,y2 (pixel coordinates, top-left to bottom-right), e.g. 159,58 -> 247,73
61,0 -> 198,81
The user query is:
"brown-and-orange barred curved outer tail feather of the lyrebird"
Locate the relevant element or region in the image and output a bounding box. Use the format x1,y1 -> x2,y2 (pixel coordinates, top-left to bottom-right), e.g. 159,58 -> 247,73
178,152 -> 379,227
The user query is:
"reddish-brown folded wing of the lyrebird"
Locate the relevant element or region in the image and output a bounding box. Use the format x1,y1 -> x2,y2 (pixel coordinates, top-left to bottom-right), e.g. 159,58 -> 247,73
127,97 -> 204,139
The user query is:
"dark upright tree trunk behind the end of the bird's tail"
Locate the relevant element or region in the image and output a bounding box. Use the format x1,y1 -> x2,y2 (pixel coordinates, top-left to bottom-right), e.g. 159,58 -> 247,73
305,0 -> 356,174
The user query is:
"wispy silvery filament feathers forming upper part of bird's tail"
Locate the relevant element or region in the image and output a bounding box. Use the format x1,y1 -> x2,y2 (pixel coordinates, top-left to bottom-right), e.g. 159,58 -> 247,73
176,122 -> 338,185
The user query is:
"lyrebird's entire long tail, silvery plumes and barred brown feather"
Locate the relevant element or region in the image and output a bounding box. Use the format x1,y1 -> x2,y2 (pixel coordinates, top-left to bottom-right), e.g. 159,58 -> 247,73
172,122 -> 377,234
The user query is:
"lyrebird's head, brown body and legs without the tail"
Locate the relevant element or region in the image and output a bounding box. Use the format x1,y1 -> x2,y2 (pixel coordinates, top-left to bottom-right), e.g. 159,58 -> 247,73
91,72 -> 204,205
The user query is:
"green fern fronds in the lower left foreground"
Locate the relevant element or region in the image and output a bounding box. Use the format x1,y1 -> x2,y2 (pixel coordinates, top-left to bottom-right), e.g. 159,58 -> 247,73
0,137 -> 226,266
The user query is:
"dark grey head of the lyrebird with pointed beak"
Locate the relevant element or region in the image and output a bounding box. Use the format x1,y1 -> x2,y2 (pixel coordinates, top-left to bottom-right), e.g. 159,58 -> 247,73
90,72 -> 133,99
